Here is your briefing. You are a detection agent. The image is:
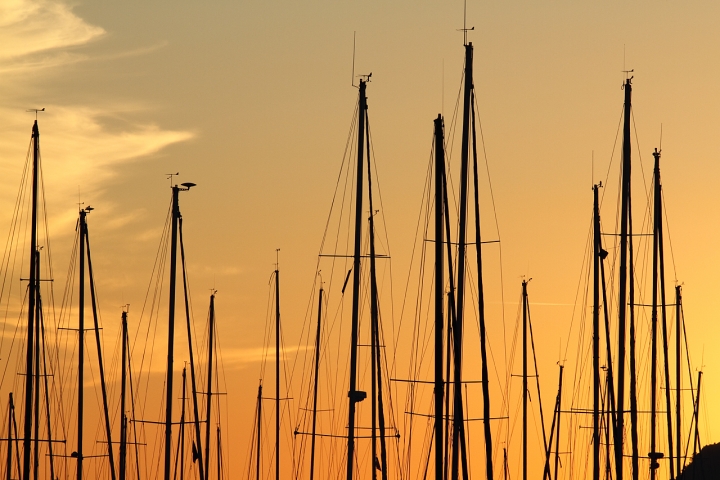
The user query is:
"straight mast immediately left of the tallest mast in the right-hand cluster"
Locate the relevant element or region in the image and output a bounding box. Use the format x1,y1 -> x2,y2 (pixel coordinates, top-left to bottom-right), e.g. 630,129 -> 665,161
592,185 -> 601,480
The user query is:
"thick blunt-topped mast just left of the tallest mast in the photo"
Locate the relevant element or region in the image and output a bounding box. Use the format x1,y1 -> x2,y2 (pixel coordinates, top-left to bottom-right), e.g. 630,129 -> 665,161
434,114 -> 445,480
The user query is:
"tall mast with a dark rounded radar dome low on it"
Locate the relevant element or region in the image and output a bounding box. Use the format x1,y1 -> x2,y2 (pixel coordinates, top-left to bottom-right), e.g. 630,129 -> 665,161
347,79 -> 367,480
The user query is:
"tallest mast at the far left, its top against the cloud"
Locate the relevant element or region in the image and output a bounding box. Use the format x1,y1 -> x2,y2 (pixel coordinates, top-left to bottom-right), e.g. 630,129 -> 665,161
23,119 -> 40,480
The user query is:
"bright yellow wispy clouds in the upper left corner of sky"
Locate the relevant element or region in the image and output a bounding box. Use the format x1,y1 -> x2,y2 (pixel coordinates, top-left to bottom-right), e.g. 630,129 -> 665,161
0,0 -> 193,229
